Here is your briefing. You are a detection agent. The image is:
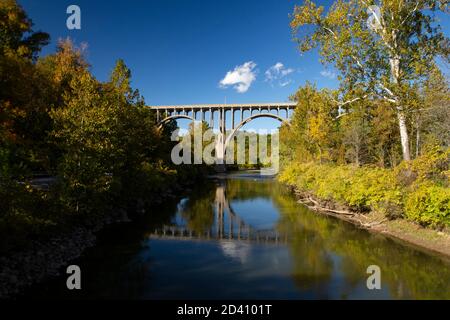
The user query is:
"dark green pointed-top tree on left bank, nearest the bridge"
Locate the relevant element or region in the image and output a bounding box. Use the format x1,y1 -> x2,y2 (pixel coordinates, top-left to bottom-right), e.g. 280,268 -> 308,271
104,60 -> 175,206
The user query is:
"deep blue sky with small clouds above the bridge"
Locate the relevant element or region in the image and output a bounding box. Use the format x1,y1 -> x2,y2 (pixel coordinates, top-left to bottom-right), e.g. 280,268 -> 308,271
19,0 -> 448,129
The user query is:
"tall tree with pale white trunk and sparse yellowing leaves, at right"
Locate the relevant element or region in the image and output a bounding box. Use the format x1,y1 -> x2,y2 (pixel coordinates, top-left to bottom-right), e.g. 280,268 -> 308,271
291,0 -> 449,160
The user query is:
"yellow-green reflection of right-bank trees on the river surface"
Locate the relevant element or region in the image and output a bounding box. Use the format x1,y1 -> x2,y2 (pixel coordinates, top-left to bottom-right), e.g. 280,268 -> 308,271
176,178 -> 450,299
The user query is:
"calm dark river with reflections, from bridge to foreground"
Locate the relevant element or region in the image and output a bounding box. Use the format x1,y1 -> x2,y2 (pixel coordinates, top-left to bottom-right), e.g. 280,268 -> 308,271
26,172 -> 450,299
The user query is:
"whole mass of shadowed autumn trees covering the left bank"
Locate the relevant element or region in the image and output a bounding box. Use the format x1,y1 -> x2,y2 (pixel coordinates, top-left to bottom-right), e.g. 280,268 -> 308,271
0,0 -> 199,251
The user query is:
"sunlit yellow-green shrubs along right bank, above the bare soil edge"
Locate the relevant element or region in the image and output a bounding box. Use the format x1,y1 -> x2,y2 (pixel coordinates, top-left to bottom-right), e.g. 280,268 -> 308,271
279,148 -> 450,231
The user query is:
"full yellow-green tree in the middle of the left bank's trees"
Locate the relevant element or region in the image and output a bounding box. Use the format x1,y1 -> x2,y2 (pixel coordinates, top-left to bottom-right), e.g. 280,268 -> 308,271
51,71 -> 114,212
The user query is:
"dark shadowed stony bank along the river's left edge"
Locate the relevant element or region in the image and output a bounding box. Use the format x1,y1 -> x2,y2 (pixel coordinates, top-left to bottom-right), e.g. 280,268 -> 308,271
0,183 -> 196,299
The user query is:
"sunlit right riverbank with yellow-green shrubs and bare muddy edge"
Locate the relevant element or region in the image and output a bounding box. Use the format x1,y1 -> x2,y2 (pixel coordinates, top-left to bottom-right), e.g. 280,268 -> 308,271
278,148 -> 450,257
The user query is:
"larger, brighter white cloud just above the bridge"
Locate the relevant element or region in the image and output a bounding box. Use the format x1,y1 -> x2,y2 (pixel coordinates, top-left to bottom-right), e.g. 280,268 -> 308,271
220,61 -> 256,93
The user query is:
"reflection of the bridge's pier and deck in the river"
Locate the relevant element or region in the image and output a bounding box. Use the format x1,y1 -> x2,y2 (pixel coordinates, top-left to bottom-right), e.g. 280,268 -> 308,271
150,182 -> 288,244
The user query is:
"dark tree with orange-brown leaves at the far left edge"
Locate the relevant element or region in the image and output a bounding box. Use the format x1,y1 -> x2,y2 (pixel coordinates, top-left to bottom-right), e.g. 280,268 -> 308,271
0,0 -> 49,175
